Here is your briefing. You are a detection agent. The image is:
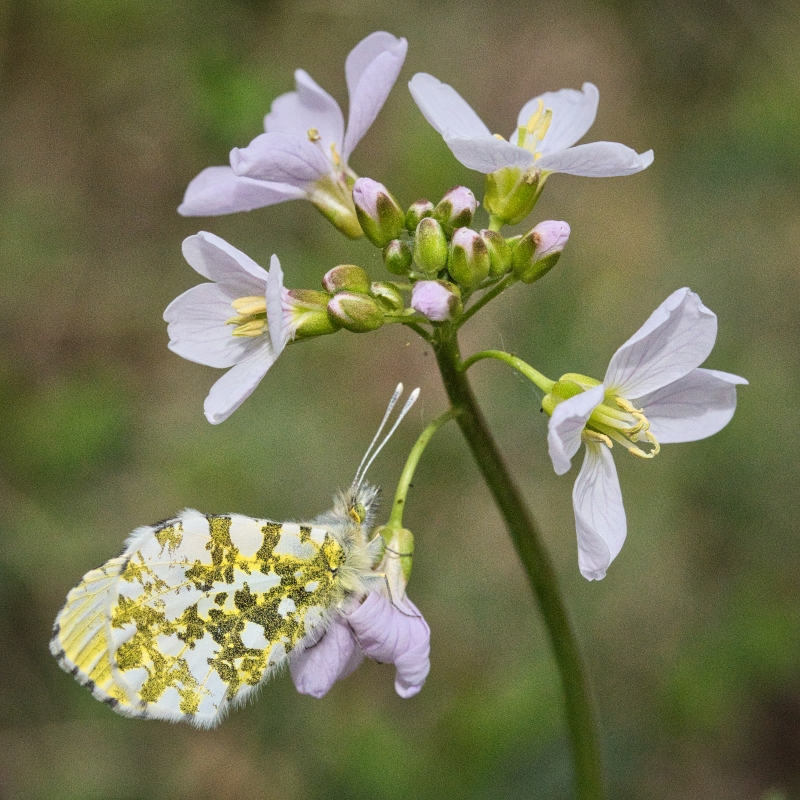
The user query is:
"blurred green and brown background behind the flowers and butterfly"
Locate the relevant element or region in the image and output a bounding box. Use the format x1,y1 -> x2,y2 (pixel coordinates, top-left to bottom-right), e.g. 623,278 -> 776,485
0,0 -> 800,800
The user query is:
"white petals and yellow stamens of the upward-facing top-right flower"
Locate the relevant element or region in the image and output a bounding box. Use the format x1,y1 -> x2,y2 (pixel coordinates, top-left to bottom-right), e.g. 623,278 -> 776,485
408,72 -> 653,178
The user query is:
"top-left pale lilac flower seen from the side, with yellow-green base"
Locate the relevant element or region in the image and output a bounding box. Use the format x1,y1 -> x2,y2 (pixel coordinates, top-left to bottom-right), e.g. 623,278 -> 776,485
178,31 -> 408,237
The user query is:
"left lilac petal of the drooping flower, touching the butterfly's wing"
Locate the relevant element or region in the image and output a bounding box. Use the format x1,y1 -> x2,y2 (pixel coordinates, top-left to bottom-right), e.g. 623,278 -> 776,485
289,617 -> 364,698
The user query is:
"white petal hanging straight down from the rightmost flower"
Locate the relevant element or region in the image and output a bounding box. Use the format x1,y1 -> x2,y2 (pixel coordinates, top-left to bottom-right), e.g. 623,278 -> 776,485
572,442 -> 628,581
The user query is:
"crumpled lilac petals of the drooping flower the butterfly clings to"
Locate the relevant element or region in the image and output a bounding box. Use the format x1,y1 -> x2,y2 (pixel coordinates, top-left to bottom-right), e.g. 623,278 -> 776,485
289,591 -> 431,697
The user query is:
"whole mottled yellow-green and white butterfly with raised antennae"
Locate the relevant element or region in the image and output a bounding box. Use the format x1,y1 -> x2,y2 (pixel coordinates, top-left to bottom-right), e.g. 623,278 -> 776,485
50,384 -> 424,727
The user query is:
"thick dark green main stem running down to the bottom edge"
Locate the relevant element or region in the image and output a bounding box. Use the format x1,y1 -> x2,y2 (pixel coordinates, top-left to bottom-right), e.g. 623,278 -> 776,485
434,329 -> 605,800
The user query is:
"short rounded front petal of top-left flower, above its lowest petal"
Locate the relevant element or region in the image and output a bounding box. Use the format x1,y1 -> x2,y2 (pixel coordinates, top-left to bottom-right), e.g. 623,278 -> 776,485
231,133 -> 331,189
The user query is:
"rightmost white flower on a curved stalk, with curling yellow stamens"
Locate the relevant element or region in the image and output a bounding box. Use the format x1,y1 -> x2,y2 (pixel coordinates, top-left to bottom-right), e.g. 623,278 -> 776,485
543,288 -> 747,580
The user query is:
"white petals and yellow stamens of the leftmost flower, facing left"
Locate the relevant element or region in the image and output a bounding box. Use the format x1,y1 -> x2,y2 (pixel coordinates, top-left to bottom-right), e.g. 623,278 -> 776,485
164,232 -> 293,424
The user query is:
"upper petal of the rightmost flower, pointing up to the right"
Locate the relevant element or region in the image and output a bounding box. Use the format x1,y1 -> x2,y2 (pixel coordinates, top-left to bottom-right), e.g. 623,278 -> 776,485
603,288 -> 717,398
